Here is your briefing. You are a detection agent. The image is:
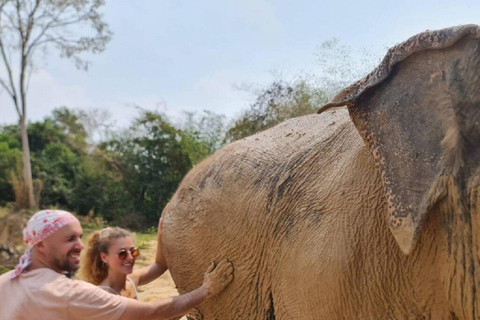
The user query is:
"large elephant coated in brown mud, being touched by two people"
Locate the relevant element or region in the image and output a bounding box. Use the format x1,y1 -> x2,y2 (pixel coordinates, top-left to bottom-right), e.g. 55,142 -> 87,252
161,25 -> 480,320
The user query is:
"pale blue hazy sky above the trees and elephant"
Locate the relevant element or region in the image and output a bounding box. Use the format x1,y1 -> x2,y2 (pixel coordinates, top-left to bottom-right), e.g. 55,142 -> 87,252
0,0 -> 480,127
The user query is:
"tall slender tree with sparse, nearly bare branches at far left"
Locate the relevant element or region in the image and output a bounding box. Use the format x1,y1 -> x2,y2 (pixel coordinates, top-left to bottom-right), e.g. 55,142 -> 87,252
0,0 -> 112,207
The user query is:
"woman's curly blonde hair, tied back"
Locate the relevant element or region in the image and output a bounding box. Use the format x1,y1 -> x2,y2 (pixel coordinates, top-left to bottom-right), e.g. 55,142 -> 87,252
79,227 -> 132,285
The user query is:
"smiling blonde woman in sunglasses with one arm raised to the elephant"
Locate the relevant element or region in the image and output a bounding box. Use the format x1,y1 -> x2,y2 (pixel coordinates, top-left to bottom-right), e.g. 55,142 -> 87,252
80,220 -> 167,300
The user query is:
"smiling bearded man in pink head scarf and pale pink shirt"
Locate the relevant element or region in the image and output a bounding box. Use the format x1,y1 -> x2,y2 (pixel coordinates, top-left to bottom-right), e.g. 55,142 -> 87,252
0,210 -> 233,320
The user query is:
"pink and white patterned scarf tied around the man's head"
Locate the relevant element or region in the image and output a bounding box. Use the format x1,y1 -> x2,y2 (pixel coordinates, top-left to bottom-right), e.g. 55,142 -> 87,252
10,210 -> 78,279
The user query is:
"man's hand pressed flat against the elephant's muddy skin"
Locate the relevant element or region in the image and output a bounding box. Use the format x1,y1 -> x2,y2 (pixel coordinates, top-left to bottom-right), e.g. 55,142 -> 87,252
202,260 -> 233,298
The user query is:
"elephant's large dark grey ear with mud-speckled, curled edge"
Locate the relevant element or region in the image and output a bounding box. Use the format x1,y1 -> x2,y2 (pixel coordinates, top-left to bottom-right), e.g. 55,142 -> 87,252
319,25 -> 480,254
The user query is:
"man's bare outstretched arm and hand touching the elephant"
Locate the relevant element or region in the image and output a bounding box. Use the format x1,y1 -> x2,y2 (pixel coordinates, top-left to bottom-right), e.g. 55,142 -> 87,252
119,260 -> 233,320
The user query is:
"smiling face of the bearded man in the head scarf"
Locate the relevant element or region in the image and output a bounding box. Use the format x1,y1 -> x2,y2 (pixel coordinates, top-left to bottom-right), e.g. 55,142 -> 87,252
43,221 -> 84,273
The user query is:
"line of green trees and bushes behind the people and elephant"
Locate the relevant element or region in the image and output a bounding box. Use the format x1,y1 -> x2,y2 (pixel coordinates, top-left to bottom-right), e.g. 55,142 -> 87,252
0,80 -> 327,229
